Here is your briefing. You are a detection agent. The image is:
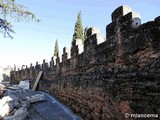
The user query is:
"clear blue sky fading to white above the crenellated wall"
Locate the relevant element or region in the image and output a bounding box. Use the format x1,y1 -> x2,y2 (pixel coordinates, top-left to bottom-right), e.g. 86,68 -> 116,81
0,0 -> 160,66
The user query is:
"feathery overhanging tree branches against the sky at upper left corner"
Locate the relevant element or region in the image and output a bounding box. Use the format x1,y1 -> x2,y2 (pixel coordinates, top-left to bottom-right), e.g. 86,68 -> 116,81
0,0 -> 39,38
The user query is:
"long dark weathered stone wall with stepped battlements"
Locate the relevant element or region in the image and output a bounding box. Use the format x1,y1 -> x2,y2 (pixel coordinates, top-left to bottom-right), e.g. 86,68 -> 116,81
11,6 -> 160,120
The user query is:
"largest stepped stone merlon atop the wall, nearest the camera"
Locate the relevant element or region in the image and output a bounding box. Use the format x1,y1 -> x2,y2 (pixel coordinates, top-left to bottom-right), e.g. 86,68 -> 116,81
106,5 -> 141,39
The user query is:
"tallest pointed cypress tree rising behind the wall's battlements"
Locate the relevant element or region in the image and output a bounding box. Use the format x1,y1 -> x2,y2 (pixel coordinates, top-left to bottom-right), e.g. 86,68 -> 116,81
72,11 -> 84,42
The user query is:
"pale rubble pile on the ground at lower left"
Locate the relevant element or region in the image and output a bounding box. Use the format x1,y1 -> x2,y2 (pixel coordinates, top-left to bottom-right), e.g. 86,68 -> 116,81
0,86 -> 46,120
